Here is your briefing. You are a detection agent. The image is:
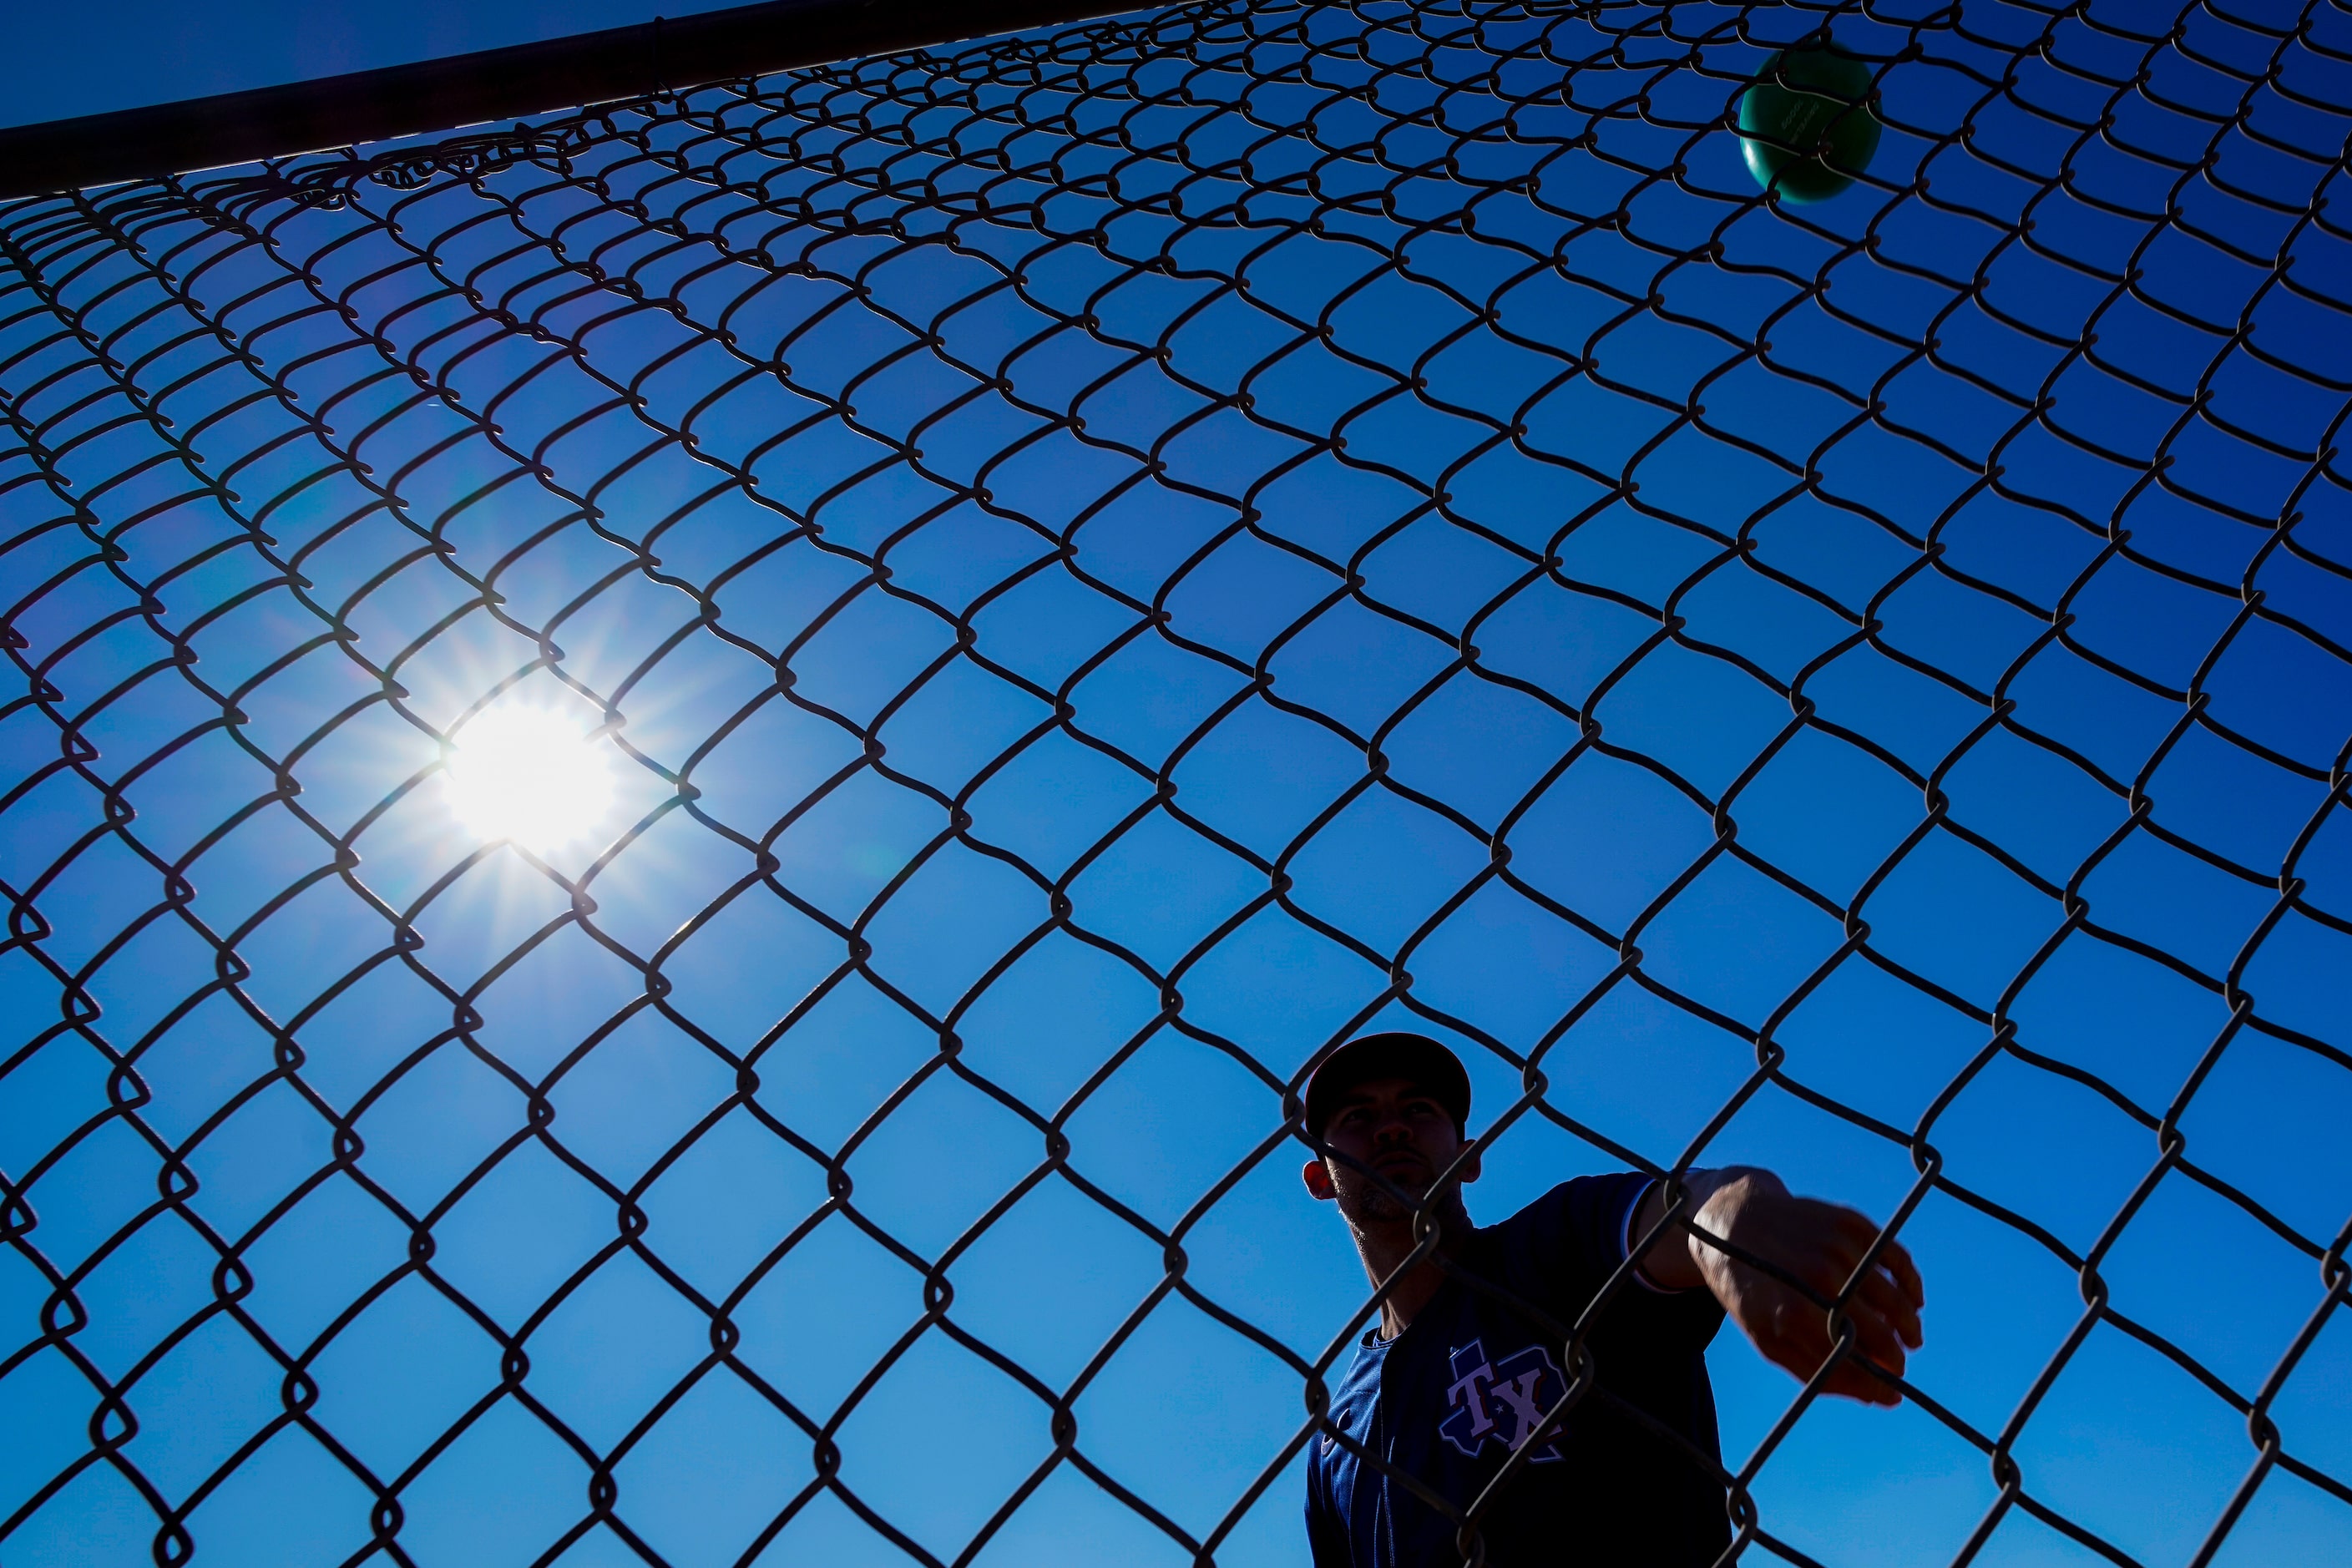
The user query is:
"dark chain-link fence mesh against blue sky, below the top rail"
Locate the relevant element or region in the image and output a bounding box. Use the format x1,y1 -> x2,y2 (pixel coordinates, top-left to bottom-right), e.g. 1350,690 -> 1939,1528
0,0 -> 2352,1565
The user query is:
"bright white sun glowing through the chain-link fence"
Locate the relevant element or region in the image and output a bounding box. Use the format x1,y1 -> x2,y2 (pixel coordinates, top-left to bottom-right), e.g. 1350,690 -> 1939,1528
444,703 -> 614,853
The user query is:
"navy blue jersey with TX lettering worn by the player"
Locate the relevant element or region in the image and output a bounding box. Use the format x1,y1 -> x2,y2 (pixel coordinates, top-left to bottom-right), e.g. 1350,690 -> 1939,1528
1308,1176 -> 1731,1568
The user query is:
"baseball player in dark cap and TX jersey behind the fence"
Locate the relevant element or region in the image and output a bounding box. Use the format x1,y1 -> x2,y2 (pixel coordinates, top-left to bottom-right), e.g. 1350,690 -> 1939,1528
1303,1034 -> 1921,1568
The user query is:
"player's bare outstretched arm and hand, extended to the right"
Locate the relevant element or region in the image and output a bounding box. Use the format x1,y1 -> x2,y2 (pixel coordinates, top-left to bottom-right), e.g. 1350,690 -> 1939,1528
1632,1166 -> 1926,1406
